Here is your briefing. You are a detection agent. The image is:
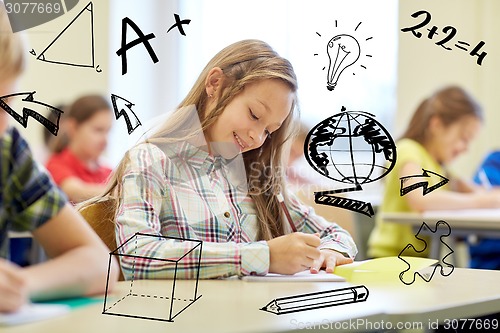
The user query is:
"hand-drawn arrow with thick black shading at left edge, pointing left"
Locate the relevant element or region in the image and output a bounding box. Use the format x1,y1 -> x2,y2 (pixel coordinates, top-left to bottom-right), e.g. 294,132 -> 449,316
0,91 -> 63,135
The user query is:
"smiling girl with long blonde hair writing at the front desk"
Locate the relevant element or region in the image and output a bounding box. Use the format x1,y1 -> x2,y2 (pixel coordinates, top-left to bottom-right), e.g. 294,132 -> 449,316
90,40 -> 356,279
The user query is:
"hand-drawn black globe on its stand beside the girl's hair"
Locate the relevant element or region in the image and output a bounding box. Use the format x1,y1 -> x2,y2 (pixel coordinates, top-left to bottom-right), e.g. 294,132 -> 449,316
304,107 -> 396,217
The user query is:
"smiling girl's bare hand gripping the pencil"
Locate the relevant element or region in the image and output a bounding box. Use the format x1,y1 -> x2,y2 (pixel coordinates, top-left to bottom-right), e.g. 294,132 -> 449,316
267,232 -> 321,274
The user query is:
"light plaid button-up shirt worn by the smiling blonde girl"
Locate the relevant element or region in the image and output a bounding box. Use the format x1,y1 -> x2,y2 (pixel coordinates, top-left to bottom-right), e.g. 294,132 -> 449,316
116,142 -> 357,279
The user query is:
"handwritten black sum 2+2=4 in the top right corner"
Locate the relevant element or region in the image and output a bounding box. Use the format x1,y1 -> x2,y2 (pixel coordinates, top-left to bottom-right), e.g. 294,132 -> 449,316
401,10 -> 487,66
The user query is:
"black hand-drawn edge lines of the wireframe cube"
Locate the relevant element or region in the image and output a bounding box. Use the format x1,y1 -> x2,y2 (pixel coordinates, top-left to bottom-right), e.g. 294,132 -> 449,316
102,232 -> 203,322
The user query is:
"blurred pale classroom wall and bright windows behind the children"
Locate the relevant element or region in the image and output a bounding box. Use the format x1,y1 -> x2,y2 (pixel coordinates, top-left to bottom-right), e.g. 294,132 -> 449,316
7,0 -> 500,262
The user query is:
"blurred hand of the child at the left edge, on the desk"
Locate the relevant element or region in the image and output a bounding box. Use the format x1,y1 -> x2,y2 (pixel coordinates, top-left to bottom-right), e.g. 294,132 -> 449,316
0,258 -> 28,312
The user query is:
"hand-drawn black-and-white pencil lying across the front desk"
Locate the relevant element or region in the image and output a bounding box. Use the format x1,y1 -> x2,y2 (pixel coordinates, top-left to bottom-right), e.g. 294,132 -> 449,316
260,286 -> 369,315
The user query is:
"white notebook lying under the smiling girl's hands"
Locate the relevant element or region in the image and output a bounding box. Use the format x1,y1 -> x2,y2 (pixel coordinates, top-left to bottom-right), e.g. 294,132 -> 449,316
241,270 -> 345,282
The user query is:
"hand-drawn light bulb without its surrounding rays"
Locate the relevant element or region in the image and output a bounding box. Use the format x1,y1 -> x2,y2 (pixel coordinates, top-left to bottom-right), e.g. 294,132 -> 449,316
326,35 -> 361,91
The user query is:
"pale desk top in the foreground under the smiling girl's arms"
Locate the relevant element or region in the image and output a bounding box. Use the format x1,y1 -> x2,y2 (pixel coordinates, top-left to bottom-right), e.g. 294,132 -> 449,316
0,268 -> 500,333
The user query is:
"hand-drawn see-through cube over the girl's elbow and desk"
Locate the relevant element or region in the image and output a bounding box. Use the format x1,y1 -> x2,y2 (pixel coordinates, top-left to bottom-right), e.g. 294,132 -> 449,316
102,232 -> 203,322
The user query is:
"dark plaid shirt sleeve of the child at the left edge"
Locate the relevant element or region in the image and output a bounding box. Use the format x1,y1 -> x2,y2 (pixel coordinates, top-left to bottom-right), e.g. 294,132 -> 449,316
0,127 -> 67,258
